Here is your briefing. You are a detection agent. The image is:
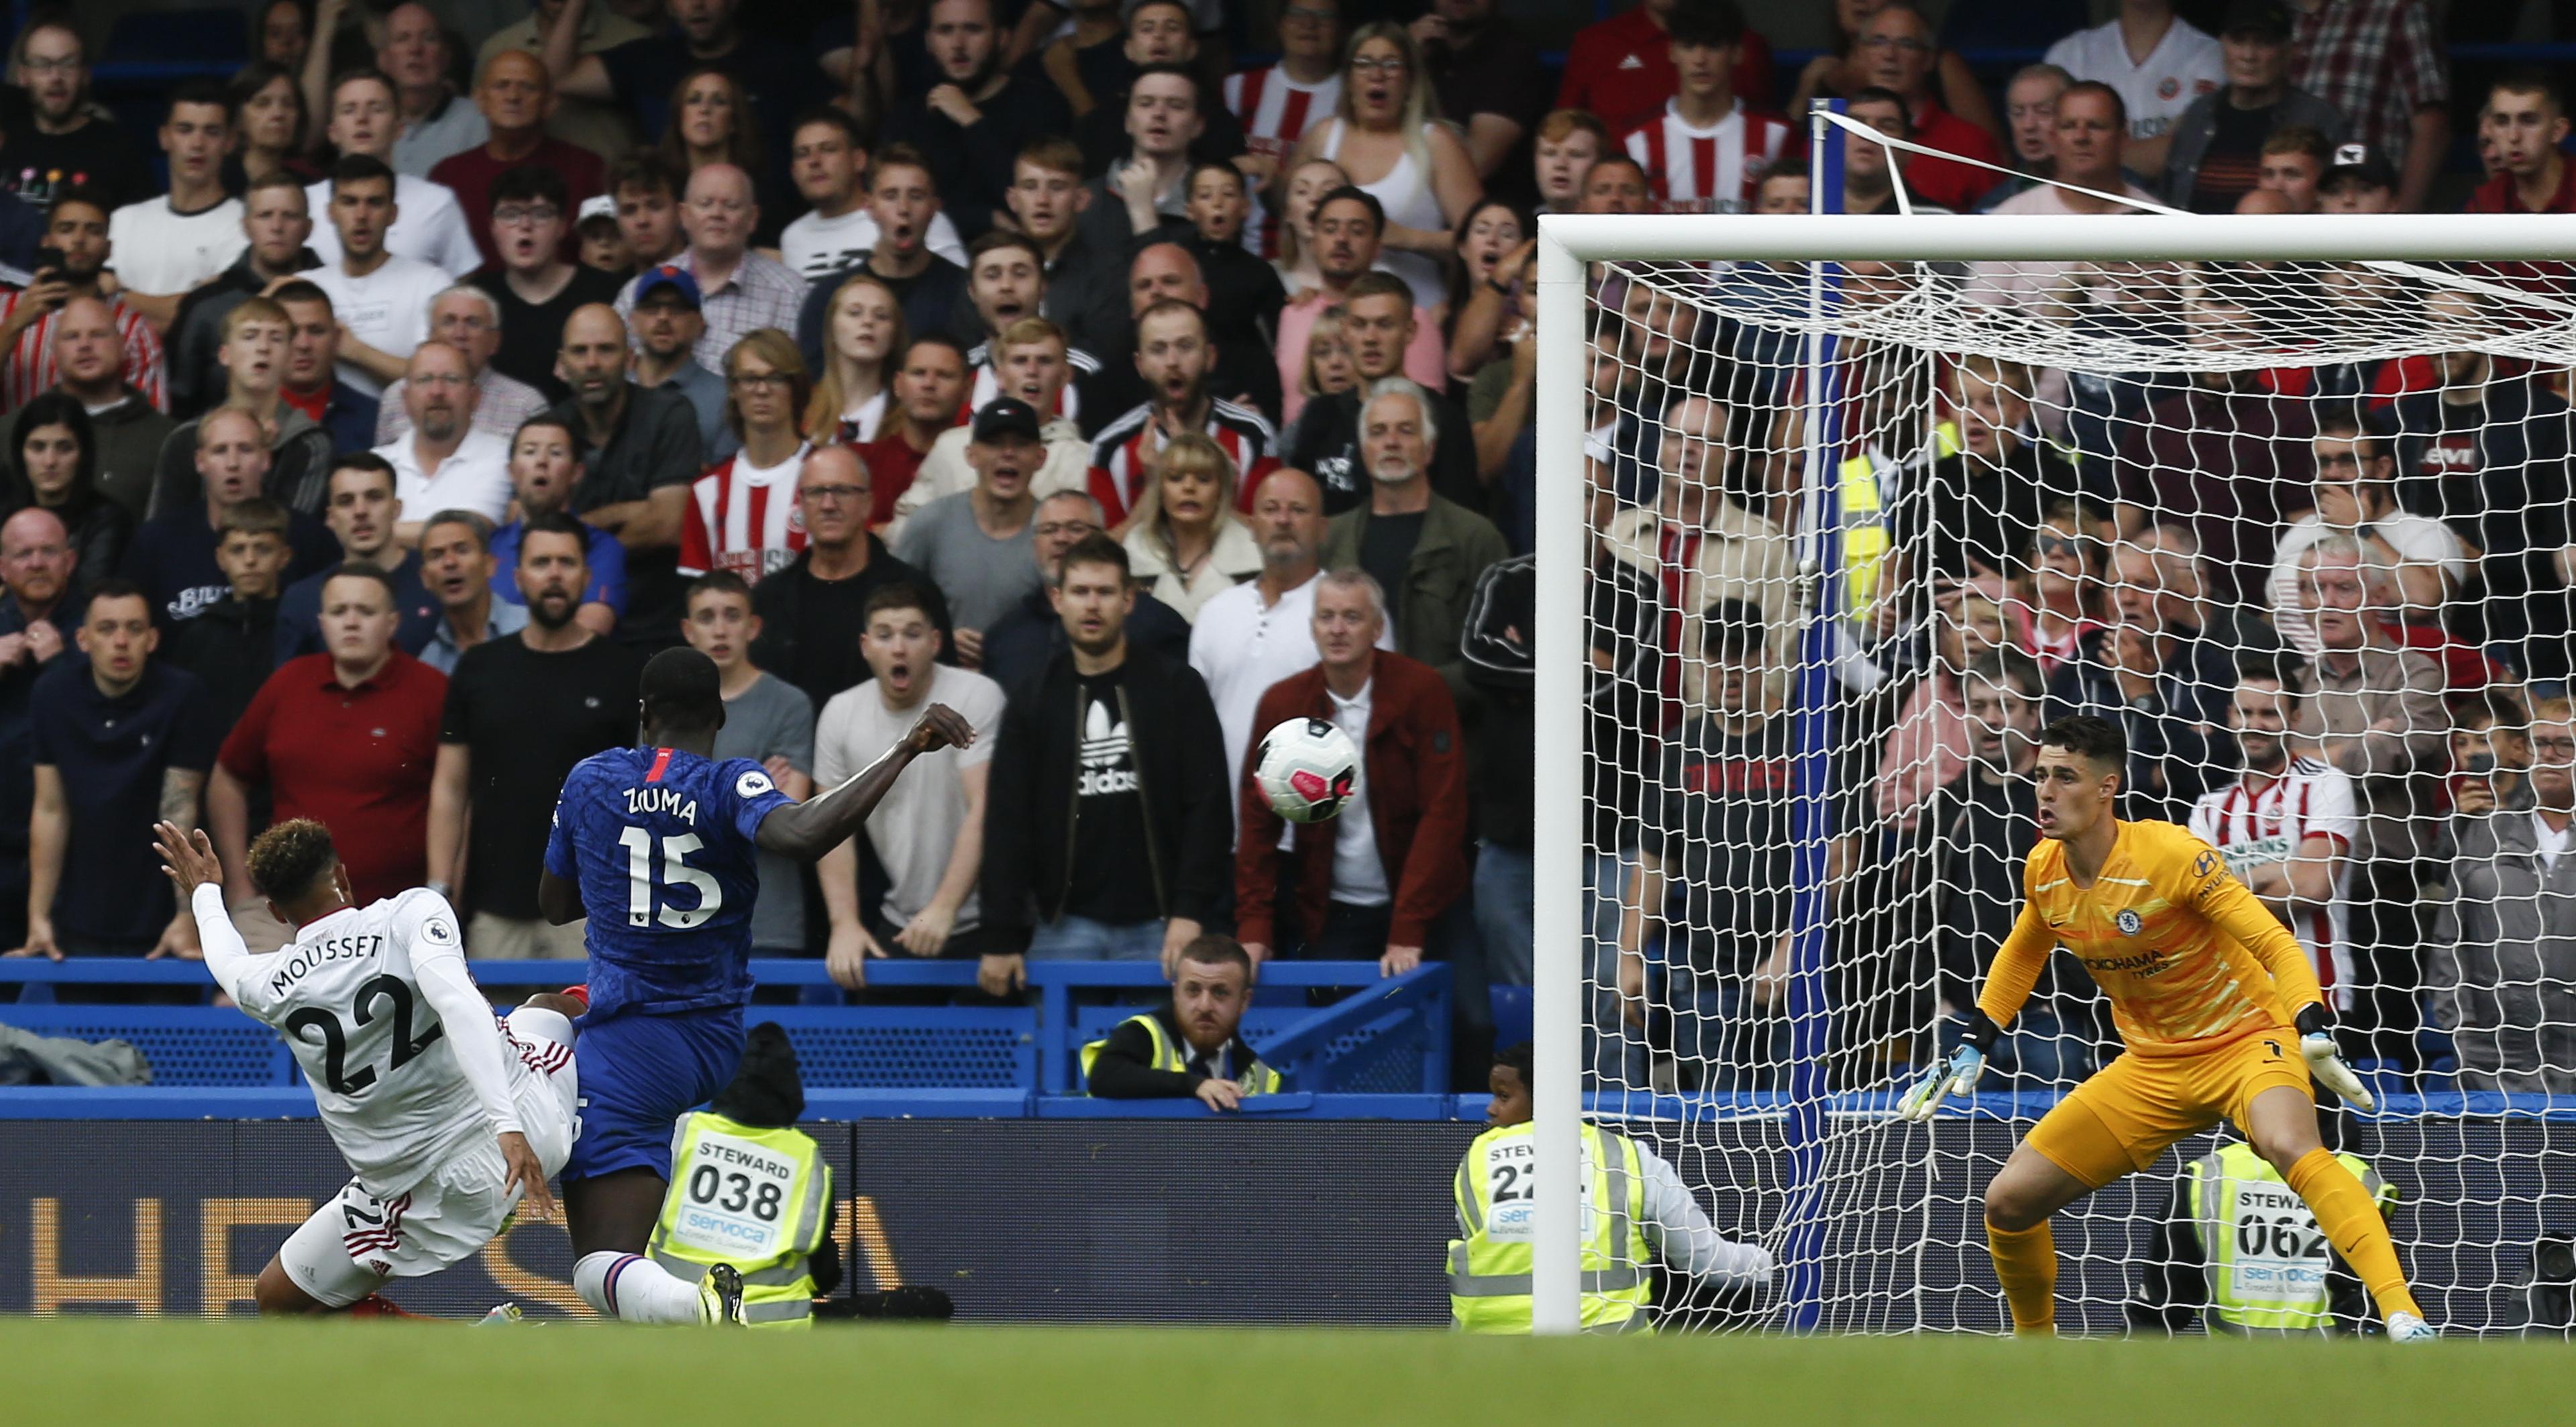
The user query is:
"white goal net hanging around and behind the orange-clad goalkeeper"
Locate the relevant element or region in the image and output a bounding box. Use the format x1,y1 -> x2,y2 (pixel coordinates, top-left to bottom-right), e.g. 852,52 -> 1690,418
1538,189 -> 2576,1332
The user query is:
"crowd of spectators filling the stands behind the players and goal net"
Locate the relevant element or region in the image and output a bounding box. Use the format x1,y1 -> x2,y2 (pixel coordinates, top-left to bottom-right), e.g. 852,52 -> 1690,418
0,0 -> 2576,1084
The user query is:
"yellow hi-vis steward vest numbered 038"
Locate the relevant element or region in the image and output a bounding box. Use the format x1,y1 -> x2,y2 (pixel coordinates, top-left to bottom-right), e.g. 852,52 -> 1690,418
644,1110 -> 832,1329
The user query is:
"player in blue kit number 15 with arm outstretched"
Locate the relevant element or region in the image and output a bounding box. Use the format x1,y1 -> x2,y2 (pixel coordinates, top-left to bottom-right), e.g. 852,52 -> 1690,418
539,649 -> 974,1324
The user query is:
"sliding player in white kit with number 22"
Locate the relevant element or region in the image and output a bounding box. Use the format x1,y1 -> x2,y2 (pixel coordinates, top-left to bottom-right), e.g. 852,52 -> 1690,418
154,819 -> 706,1314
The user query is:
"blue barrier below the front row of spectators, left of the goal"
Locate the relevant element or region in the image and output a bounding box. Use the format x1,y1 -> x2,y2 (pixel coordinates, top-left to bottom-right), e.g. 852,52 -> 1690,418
0,958 -> 1450,1095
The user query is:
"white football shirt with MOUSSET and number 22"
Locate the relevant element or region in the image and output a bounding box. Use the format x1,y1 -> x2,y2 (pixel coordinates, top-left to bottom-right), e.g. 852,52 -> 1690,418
193,884 -> 533,1198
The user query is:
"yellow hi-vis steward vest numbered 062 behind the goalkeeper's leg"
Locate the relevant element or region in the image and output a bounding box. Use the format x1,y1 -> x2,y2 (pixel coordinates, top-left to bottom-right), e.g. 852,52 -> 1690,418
2182,1141 -> 2398,1334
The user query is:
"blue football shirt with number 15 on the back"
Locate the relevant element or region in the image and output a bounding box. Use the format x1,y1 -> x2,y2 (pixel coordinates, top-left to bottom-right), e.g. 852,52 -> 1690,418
546,747 -> 796,1018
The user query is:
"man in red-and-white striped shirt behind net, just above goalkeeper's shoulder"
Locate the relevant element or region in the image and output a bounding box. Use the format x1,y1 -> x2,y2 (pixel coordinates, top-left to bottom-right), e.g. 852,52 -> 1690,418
2192,670 -> 2357,1010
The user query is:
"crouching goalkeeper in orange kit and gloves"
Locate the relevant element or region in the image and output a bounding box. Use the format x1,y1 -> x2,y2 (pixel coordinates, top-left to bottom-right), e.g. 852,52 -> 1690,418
1896,716 -> 2434,1342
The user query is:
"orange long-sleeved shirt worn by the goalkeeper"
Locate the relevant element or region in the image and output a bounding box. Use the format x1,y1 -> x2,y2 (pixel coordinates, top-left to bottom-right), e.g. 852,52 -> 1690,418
1976,822 -> 2324,1056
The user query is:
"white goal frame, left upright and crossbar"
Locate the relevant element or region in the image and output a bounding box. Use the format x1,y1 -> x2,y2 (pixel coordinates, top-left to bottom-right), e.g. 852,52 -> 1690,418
1533,214 -> 2576,1334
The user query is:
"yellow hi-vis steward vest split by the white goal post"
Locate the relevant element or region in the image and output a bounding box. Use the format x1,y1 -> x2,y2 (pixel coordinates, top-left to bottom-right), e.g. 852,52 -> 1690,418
1450,1123 -> 1654,1332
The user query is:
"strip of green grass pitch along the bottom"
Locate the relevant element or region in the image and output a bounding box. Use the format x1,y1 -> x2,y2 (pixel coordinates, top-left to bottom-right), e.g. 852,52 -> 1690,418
0,1319 -> 2576,1427
